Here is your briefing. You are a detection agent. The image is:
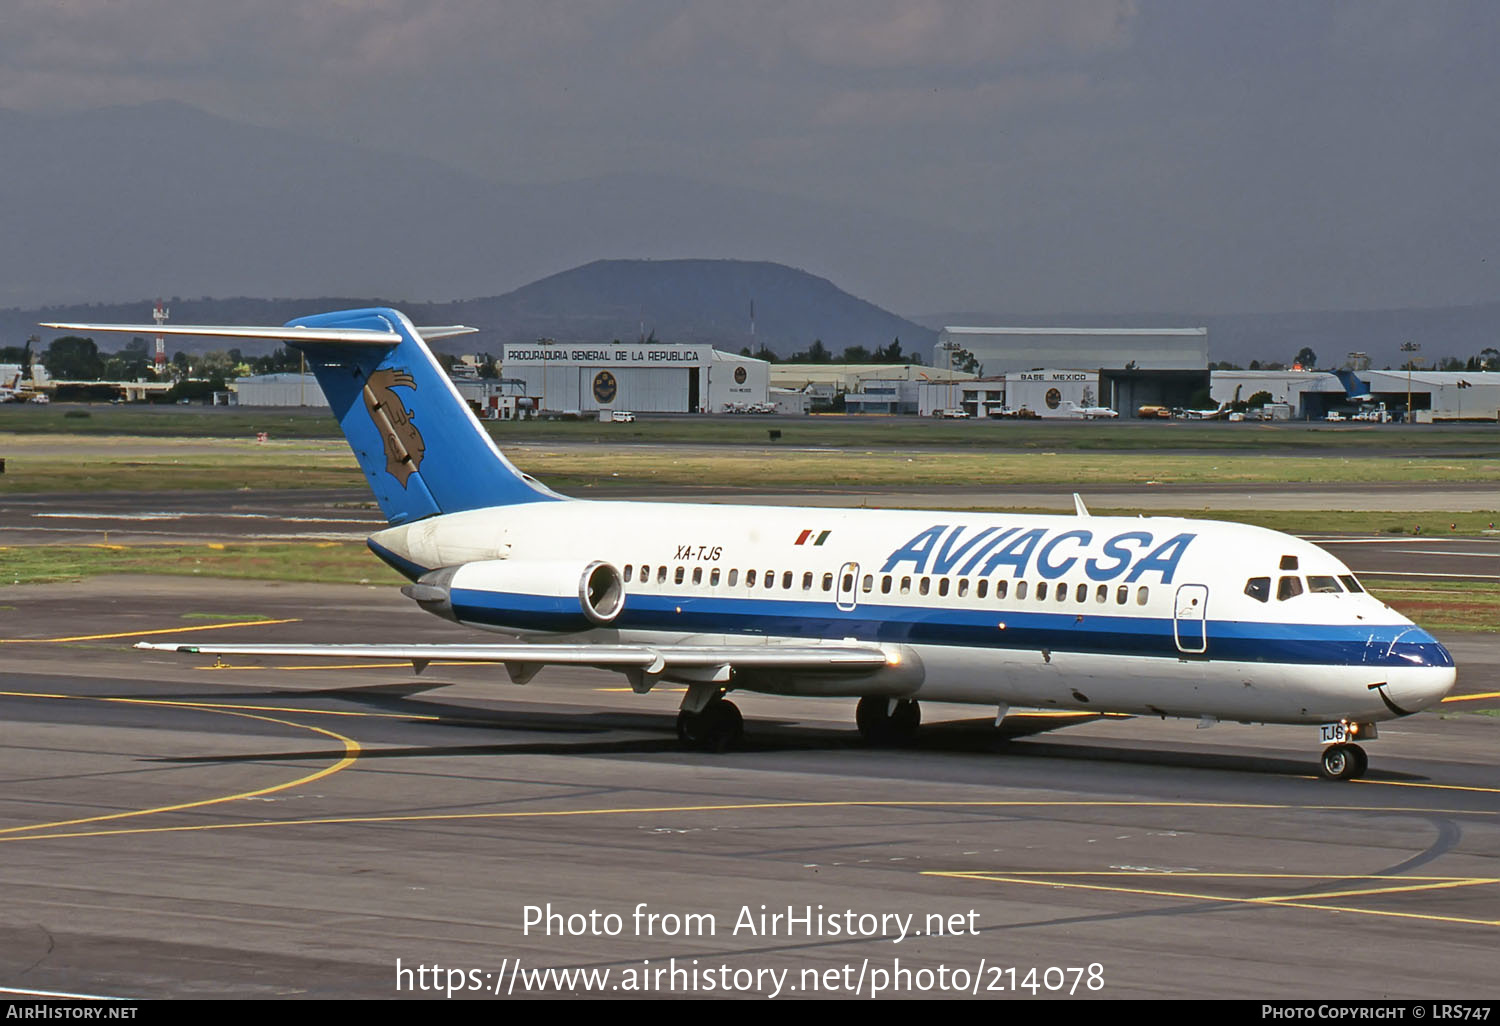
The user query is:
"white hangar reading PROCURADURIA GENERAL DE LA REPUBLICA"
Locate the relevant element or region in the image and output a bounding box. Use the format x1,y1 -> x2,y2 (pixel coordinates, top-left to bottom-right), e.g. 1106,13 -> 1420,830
501,342 -> 771,413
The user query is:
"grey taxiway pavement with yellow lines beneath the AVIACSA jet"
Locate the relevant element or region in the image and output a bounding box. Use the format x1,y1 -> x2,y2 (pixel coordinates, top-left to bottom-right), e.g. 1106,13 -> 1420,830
0,578 -> 1500,999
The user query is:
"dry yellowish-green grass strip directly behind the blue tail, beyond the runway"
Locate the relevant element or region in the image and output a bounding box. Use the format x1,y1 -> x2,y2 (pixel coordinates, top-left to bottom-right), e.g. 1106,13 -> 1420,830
0,435 -> 1500,495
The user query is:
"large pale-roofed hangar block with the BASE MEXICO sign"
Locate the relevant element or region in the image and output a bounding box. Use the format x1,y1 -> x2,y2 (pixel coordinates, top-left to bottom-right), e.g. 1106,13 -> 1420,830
936,327 -> 1209,417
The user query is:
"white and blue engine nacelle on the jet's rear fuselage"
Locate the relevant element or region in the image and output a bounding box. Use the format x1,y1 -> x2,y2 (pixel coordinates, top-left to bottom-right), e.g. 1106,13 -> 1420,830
402,560 -> 626,633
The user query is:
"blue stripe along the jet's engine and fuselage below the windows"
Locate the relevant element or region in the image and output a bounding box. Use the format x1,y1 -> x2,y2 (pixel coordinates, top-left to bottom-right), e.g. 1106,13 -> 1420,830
452,588 -> 1454,668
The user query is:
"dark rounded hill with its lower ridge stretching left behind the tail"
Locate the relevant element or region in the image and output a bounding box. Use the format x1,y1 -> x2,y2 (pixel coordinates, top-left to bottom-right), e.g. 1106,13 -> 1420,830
0,260 -> 936,360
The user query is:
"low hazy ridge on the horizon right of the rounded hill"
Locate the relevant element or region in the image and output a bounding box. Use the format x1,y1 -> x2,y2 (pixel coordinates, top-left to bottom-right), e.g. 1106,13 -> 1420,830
912,303 -> 1500,368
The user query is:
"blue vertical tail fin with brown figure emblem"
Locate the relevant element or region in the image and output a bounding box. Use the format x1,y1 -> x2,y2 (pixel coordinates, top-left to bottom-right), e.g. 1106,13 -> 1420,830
288,308 -> 561,524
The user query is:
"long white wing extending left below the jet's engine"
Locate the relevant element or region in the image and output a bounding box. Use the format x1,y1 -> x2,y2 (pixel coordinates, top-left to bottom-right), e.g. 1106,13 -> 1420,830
137,642 -> 902,680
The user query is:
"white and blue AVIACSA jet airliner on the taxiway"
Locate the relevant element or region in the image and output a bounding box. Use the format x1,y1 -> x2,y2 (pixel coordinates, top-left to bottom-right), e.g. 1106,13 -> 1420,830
48,308 -> 1455,779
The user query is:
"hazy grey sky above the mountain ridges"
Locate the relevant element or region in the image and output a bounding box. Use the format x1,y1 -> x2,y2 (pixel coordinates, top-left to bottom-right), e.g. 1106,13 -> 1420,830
0,0 -> 1500,312
